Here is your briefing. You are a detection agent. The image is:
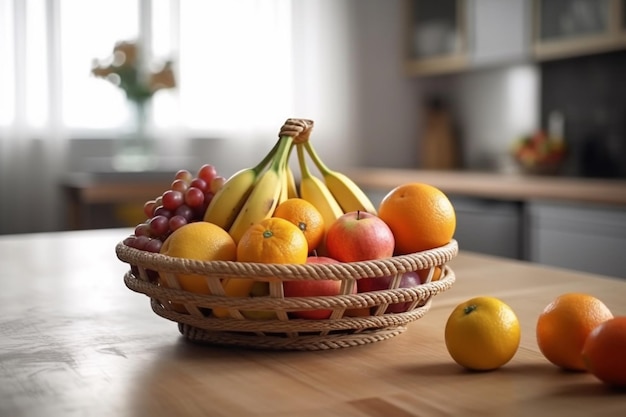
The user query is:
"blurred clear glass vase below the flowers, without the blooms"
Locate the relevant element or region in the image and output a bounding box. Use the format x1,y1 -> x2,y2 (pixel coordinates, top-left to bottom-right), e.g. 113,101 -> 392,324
113,101 -> 157,171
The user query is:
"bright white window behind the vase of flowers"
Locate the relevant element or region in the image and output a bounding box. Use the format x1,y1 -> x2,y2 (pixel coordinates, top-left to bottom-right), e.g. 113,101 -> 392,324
0,0 -> 292,136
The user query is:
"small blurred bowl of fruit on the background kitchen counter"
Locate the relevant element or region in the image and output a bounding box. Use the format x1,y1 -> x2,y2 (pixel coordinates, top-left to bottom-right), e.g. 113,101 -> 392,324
512,130 -> 566,175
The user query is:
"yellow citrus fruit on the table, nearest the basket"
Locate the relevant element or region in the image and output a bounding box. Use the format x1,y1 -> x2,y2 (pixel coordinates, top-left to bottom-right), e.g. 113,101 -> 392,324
445,296 -> 521,371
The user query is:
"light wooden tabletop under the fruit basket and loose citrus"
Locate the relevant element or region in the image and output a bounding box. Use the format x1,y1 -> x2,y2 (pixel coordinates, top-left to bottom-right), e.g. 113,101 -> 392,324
0,229 -> 626,417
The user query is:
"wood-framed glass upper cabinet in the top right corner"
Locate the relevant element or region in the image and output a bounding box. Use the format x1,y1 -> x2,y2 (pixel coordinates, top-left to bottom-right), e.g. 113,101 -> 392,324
533,0 -> 626,60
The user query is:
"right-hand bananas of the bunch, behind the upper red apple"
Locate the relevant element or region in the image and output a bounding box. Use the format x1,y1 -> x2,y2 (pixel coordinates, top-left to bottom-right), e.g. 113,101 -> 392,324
298,141 -> 376,221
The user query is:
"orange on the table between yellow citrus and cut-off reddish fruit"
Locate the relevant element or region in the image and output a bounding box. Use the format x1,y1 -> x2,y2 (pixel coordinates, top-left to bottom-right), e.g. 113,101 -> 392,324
536,293 -> 613,371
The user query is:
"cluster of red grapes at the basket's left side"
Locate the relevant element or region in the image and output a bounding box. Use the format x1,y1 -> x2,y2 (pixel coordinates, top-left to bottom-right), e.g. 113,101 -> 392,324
124,164 -> 226,253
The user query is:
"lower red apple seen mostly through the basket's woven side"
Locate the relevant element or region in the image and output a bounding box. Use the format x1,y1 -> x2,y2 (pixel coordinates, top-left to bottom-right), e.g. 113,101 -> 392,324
283,256 -> 356,320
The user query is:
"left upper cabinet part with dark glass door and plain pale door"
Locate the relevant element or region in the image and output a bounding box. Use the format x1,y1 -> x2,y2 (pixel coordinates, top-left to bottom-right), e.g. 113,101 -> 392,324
405,0 -> 530,75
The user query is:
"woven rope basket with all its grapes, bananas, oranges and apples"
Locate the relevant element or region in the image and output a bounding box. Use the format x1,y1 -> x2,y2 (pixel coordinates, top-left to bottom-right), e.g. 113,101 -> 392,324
116,119 -> 458,350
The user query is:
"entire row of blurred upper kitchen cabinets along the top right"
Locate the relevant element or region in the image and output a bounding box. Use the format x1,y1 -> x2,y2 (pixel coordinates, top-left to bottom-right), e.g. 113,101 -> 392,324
404,0 -> 626,75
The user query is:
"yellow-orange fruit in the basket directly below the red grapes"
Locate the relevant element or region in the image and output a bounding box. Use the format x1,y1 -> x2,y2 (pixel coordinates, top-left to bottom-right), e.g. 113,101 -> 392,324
159,222 -> 237,311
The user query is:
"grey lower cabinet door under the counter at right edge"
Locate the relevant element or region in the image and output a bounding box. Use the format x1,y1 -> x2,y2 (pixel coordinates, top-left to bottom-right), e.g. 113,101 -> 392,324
528,202 -> 626,278
